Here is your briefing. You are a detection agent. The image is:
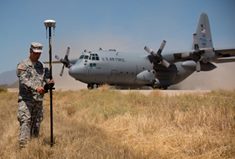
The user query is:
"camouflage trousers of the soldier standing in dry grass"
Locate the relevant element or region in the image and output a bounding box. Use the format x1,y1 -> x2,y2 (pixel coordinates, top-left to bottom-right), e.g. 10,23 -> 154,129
17,100 -> 43,144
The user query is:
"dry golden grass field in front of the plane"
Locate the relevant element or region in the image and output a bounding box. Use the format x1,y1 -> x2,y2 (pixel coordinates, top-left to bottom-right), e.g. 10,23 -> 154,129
0,88 -> 235,159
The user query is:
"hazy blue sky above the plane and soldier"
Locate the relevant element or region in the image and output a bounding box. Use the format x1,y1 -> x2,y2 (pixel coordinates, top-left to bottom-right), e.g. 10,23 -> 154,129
0,0 -> 235,73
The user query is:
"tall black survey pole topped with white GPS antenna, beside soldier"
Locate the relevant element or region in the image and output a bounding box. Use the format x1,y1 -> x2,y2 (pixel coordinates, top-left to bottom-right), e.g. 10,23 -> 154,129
44,20 -> 56,147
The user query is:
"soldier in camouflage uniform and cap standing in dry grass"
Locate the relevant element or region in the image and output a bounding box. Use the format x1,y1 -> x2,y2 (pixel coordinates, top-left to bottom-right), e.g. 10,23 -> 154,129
17,42 -> 54,147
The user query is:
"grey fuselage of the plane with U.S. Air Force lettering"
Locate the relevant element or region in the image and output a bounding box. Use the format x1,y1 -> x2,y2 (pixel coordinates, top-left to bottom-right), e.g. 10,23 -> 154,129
69,50 -> 195,87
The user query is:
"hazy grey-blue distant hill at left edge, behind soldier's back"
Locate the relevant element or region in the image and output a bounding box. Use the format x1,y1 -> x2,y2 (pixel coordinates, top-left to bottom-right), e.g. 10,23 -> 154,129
0,70 -> 17,85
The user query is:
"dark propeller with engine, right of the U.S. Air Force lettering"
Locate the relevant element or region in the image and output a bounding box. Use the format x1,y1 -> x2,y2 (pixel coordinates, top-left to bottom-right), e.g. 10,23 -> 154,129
144,40 -> 170,68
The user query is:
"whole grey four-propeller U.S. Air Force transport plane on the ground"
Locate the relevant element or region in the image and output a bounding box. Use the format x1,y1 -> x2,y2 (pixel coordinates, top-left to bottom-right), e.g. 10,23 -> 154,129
53,13 -> 235,89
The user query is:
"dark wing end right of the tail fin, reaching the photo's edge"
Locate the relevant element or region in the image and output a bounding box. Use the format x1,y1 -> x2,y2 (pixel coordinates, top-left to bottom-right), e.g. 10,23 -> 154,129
213,49 -> 235,63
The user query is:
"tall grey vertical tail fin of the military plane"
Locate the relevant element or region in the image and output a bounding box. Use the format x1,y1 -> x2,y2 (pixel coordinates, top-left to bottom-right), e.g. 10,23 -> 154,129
193,13 -> 213,50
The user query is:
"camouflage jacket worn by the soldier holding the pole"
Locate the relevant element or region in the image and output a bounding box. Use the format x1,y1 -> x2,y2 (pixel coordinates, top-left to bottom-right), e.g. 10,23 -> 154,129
16,58 -> 49,101
